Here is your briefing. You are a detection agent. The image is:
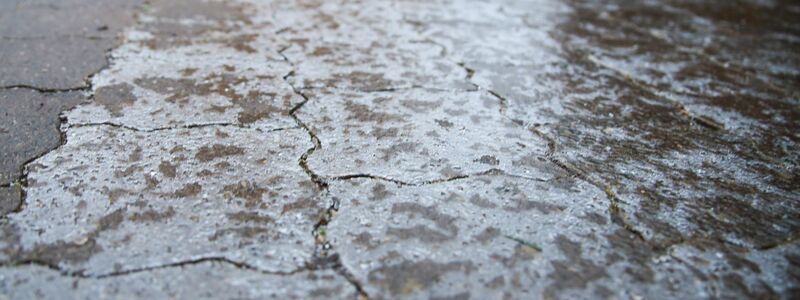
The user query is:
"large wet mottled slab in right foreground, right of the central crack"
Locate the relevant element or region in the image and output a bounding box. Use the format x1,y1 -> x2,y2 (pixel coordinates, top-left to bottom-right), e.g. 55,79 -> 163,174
325,174 -> 797,299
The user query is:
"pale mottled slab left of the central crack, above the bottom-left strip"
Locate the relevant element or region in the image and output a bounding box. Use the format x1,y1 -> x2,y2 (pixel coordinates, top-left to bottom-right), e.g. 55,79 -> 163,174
0,126 -> 324,275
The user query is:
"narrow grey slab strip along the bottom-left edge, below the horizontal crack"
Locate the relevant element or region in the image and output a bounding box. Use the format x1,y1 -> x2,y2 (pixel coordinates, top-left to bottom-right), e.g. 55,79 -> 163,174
0,262 -> 356,299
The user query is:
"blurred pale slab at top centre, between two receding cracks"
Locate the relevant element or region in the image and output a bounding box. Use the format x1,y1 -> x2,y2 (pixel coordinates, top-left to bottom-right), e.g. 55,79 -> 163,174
270,1 -> 472,91
